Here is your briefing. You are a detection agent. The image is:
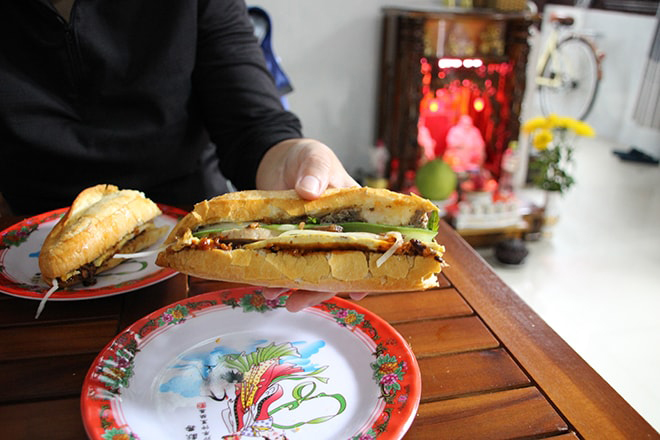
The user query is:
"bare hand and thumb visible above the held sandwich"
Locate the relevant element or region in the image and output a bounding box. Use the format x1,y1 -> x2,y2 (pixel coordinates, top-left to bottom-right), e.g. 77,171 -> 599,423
256,139 -> 358,200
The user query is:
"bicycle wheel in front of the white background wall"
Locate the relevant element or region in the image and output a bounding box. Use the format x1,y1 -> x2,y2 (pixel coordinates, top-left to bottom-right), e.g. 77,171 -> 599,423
538,36 -> 600,120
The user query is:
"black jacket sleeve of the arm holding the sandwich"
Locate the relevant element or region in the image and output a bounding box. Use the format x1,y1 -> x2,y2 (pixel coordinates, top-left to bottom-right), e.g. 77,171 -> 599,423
193,0 -> 301,189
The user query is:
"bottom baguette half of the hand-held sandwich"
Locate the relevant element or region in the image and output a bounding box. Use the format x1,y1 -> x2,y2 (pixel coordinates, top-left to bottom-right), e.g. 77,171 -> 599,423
156,249 -> 442,292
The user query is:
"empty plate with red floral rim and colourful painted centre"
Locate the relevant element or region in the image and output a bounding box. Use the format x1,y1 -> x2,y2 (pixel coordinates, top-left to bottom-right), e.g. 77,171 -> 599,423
81,287 -> 421,440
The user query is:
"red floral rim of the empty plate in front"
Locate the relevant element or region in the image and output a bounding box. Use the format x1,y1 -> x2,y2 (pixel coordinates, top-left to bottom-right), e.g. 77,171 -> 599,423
81,287 -> 421,440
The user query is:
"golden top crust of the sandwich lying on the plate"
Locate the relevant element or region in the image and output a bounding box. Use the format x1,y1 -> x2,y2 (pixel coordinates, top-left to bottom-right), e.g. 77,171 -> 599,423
39,185 -> 161,281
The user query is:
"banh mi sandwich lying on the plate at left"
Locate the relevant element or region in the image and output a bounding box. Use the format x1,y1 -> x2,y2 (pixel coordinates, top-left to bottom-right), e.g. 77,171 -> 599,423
39,185 -> 167,287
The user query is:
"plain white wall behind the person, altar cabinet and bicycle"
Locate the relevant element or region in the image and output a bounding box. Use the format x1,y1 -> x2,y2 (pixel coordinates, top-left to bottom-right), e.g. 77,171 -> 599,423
254,0 -> 660,180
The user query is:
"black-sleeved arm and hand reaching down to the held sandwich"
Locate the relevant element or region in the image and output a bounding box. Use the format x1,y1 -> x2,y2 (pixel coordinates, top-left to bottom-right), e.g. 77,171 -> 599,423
193,0 -> 357,199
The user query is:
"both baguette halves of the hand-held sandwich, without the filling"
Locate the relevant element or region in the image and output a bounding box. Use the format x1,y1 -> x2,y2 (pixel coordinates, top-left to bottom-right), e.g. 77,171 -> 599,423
156,188 -> 444,291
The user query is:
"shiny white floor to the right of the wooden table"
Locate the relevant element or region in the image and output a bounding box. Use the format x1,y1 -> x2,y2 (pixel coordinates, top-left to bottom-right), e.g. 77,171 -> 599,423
480,139 -> 660,431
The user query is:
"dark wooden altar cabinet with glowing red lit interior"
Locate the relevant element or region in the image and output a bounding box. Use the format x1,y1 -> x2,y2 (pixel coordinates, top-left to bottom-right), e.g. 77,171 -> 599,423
378,11 -> 533,190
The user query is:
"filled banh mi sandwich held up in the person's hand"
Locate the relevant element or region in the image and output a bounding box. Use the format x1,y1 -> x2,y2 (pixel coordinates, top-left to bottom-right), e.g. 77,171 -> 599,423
156,187 -> 444,292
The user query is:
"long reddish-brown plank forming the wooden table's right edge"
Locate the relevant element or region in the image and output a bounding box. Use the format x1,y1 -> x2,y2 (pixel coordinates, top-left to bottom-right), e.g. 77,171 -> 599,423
438,222 -> 660,438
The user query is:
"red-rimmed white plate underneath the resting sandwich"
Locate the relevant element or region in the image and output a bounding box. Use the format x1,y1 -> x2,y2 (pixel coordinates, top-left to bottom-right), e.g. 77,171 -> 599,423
0,205 -> 186,301
